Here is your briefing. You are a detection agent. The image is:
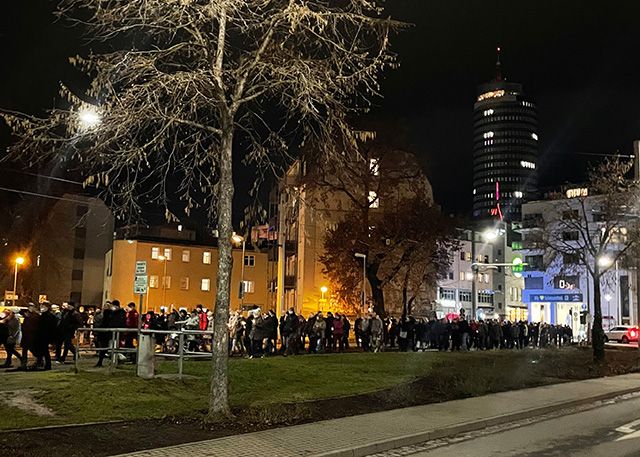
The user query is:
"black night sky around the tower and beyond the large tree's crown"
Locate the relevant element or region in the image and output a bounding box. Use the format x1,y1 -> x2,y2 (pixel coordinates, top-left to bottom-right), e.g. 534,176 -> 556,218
0,0 -> 640,216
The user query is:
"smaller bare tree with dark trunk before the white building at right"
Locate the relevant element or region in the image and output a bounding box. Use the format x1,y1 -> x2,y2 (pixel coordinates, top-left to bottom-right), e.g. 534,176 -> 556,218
529,159 -> 640,360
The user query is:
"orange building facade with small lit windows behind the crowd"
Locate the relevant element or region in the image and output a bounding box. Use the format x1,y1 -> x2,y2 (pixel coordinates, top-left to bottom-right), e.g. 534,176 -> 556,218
103,240 -> 268,311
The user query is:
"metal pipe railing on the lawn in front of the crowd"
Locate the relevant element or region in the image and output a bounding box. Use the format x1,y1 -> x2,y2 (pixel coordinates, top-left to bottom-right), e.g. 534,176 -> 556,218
74,328 -> 213,378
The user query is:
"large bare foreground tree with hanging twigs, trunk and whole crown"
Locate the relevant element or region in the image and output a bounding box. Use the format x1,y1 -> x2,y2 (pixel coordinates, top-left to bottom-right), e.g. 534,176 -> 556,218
5,0 -> 399,420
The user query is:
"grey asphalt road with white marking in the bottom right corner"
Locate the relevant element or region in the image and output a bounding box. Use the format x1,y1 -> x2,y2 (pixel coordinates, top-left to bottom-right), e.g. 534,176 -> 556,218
375,396 -> 640,457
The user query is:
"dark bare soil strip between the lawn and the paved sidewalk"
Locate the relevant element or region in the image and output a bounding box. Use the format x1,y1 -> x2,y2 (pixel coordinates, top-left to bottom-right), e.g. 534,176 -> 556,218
0,349 -> 640,457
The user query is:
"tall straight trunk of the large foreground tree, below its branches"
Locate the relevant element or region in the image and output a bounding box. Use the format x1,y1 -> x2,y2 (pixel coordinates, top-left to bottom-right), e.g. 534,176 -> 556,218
207,128 -> 234,422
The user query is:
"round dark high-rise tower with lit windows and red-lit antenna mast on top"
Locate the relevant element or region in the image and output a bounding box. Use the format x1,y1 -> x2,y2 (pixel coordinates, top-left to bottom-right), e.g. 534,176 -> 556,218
473,48 -> 538,222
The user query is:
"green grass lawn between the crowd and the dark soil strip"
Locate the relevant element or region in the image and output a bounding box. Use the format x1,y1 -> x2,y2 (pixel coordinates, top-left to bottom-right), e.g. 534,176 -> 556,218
0,349 -> 637,429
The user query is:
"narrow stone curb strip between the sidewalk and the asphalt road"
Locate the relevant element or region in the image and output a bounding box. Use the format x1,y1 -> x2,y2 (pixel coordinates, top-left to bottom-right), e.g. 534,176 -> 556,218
312,387 -> 640,457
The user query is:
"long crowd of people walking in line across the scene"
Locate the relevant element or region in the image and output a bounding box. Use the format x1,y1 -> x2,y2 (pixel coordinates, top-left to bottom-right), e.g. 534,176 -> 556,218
0,300 -> 573,370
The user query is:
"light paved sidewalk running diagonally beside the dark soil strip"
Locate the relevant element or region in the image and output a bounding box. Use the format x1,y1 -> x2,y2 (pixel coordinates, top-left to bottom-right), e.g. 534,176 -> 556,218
112,374 -> 640,457
